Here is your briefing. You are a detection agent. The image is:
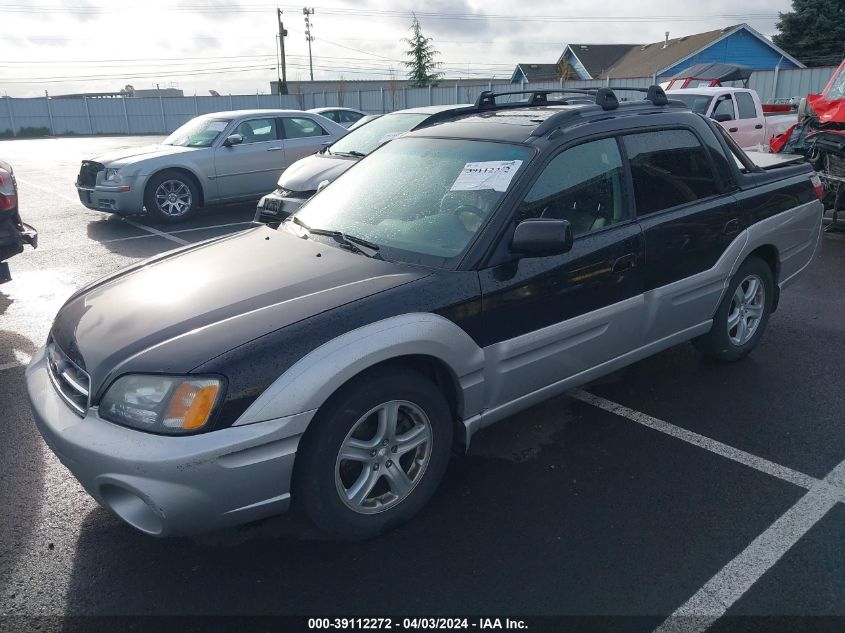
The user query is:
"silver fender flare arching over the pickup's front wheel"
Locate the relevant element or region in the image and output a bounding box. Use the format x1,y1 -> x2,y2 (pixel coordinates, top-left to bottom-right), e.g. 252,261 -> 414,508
235,313 -> 484,426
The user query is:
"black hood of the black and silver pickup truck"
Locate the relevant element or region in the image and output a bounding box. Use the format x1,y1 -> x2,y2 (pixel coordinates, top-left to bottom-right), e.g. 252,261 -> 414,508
51,227 -> 428,402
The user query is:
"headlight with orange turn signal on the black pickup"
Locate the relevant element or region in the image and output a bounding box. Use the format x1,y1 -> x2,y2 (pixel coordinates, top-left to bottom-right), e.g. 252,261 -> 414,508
100,374 -> 224,435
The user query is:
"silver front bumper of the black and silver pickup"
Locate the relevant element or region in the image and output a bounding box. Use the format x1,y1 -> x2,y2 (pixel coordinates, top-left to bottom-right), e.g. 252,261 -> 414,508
26,348 -> 314,536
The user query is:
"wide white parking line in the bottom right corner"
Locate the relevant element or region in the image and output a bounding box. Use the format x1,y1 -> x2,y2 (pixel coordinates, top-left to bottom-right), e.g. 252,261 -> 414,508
654,462 -> 845,633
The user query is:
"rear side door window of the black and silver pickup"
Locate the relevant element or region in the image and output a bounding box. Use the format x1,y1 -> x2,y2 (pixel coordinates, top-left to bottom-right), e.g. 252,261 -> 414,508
623,130 -> 719,216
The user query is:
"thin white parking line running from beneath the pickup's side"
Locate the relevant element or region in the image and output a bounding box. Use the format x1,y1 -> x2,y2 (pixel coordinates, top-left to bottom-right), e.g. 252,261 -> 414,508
570,389 -> 819,490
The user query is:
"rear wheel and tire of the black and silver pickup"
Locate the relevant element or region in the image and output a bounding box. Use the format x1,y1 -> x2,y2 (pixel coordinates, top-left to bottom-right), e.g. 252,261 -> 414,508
692,257 -> 774,362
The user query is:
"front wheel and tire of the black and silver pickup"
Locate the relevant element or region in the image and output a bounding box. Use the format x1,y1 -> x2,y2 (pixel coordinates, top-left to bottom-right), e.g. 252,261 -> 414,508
294,367 -> 453,539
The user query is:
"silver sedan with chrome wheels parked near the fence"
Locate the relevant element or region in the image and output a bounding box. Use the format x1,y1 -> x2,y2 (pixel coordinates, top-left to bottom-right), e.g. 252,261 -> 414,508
76,110 -> 346,222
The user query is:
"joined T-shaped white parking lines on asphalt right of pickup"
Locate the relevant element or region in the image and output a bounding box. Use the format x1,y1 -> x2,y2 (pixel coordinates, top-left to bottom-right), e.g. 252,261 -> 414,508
570,389 -> 845,633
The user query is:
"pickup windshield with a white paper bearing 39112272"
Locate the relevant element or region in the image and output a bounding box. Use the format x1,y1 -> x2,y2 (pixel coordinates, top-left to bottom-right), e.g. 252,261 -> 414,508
285,137 -> 533,266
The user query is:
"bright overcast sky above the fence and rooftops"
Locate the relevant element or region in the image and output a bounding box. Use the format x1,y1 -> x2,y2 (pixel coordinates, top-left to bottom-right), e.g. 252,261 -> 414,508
0,0 -> 789,97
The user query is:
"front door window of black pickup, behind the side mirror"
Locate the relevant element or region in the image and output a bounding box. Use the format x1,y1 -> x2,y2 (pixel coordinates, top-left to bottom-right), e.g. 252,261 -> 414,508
517,138 -> 628,235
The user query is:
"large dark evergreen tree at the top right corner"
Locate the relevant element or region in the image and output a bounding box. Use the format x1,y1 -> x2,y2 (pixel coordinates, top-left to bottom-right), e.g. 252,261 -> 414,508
772,0 -> 845,66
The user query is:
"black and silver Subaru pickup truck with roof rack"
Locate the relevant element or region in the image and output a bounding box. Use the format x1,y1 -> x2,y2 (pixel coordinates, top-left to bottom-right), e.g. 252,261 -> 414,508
27,86 -> 822,538
